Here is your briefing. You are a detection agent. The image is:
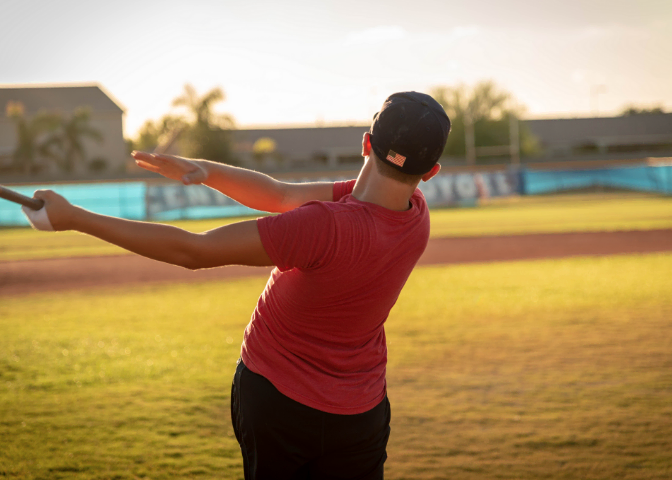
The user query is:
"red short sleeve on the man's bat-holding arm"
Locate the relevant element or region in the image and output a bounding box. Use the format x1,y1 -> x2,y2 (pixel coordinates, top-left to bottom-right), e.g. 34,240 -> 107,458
257,202 -> 336,272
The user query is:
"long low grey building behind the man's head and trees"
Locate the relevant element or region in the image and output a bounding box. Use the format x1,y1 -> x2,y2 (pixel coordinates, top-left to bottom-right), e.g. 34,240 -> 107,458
233,113 -> 672,169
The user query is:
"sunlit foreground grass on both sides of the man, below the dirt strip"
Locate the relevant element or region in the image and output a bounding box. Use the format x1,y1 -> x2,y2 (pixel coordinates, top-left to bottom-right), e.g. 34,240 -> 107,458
0,254 -> 672,479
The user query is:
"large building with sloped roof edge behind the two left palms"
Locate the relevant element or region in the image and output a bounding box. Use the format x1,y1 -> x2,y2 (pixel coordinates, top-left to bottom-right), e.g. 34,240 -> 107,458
0,84 -> 128,172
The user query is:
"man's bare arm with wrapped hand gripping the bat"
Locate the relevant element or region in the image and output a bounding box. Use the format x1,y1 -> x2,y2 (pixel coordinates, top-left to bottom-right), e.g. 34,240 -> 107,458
35,190 -> 273,270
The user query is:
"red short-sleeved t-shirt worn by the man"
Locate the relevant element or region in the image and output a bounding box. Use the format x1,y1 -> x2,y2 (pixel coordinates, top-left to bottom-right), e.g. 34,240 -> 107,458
241,180 -> 429,415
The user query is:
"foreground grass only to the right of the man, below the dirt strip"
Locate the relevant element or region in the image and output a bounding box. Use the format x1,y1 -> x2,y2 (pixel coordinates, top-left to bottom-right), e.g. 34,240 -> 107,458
388,254 -> 672,479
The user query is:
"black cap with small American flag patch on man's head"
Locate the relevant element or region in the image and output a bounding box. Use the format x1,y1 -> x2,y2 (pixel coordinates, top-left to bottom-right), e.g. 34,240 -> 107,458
369,92 -> 450,175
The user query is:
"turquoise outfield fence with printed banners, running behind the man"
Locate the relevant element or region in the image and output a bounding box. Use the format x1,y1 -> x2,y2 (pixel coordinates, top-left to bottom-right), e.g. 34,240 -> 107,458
0,165 -> 672,226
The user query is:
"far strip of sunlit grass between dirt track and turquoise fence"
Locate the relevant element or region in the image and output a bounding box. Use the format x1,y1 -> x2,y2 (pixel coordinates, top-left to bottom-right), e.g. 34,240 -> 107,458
0,193 -> 672,261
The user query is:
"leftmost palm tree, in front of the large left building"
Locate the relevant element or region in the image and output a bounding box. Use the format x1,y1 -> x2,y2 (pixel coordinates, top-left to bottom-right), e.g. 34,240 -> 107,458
7,102 -> 61,174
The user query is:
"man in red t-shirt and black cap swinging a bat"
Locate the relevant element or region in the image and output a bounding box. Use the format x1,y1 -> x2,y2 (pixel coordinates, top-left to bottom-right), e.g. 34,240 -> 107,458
22,92 -> 450,480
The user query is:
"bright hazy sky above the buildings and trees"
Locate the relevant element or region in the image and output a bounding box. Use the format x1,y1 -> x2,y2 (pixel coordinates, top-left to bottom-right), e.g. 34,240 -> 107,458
0,0 -> 672,137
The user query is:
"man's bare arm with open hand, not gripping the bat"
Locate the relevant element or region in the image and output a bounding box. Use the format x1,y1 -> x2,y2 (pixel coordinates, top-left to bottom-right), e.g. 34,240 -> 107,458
132,152 -> 334,213
